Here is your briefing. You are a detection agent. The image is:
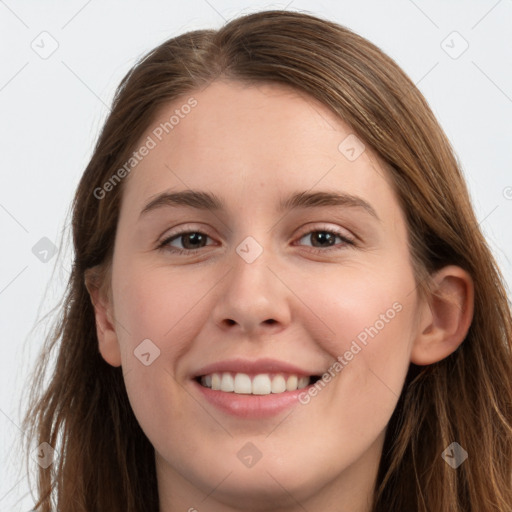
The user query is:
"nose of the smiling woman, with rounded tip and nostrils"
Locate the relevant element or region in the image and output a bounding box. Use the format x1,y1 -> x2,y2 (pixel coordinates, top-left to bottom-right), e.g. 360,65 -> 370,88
213,242 -> 293,338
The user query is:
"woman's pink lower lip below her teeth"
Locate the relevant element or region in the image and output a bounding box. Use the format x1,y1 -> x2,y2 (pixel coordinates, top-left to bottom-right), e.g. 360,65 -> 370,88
193,380 -> 313,419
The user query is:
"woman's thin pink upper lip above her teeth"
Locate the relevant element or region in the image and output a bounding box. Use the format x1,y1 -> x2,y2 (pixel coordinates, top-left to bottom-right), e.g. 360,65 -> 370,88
193,358 -> 322,378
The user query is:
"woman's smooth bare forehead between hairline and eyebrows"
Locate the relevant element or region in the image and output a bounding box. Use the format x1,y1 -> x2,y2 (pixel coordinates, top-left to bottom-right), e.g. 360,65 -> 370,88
121,81 -> 400,219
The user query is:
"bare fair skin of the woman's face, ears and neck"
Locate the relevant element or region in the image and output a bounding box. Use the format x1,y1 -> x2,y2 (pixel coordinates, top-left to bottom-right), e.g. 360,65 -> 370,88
89,81 -> 473,512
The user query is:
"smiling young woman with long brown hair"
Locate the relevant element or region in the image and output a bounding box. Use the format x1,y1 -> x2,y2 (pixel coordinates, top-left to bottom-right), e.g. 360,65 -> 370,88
25,11 -> 512,512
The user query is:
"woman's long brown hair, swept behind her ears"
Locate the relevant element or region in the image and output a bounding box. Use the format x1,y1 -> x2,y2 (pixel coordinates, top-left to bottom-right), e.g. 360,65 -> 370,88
24,10 -> 512,512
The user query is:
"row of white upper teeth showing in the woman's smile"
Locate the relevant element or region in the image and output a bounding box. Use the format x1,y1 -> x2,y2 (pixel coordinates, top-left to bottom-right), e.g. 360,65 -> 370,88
201,372 -> 310,395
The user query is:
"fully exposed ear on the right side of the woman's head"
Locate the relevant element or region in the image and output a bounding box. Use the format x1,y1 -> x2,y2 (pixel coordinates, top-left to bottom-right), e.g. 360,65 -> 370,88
411,265 -> 474,366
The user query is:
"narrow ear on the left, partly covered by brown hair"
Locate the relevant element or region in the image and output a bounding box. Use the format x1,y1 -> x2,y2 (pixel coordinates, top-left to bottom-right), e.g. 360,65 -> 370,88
85,267 -> 121,366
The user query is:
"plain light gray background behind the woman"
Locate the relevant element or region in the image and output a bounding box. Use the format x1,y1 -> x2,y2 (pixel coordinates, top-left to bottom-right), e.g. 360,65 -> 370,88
0,0 -> 512,512
